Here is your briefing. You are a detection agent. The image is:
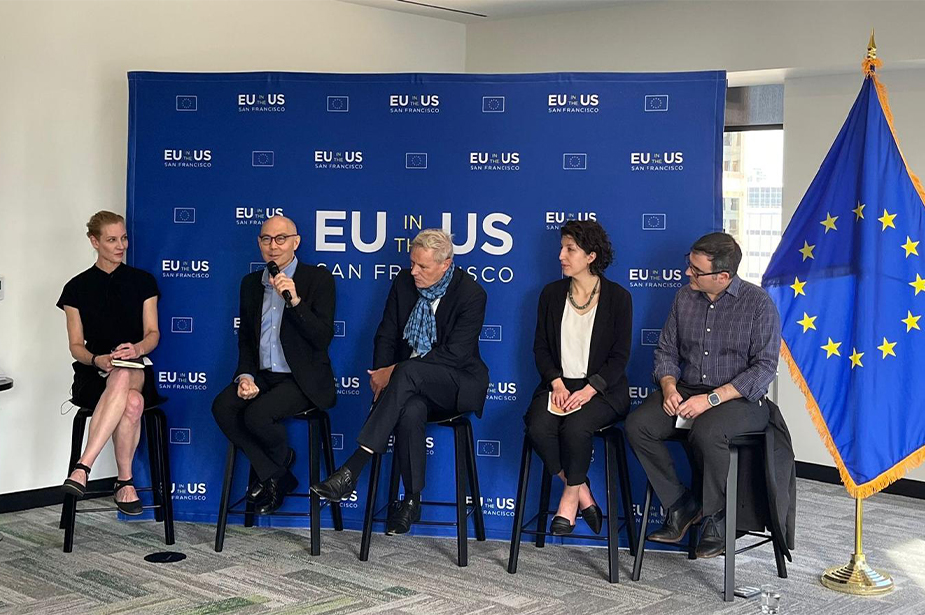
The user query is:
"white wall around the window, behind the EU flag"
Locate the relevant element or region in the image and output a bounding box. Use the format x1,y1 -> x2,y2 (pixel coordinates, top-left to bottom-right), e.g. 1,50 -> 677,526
466,1 -> 925,480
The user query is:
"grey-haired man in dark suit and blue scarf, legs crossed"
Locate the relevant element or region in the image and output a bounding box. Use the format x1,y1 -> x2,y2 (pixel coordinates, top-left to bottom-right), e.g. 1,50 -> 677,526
312,229 -> 488,534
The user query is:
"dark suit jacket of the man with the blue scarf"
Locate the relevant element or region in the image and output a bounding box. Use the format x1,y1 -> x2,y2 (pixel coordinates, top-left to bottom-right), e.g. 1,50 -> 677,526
373,268 -> 488,417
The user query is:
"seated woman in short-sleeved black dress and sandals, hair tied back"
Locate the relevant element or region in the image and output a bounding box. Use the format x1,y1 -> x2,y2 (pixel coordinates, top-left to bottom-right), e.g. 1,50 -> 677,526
58,211 -> 160,515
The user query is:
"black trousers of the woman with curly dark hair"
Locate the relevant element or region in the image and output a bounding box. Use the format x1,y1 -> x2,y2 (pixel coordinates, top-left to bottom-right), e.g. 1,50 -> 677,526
524,379 -> 620,486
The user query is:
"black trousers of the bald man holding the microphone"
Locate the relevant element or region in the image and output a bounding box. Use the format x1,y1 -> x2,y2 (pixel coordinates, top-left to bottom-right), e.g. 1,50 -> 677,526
212,370 -> 314,481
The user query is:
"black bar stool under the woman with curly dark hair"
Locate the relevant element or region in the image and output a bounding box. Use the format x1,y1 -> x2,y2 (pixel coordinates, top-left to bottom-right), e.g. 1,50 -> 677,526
507,425 -> 636,583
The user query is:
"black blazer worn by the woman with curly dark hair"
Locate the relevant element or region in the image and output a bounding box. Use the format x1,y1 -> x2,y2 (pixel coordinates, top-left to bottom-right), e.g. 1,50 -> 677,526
533,276 -> 633,414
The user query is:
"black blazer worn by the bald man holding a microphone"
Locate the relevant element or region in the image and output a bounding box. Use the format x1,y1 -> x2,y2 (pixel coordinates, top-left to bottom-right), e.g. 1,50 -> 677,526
234,262 -> 337,409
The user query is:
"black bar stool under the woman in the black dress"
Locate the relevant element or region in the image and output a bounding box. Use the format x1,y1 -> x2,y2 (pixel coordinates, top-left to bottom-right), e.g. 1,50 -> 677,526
60,397 -> 174,553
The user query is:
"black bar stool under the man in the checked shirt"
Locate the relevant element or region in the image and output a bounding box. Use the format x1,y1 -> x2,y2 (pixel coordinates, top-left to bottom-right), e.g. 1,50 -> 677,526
633,425 -> 789,602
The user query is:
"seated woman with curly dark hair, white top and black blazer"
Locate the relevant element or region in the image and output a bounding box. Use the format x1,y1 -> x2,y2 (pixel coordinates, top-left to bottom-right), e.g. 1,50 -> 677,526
524,220 -> 633,535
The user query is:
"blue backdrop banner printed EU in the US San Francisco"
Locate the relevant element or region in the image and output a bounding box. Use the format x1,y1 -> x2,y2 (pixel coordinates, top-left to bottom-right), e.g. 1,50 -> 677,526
127,71 -> 726,538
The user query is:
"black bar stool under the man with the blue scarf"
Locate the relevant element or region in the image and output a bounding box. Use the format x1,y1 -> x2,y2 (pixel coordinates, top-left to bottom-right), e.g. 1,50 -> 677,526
360,414 -> 485,567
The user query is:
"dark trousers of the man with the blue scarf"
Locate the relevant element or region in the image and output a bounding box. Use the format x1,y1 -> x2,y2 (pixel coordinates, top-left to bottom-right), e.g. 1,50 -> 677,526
357,359 -> 459,495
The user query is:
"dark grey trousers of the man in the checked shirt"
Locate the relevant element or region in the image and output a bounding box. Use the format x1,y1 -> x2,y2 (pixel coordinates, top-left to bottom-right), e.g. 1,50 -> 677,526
626,384 -> 768,515
